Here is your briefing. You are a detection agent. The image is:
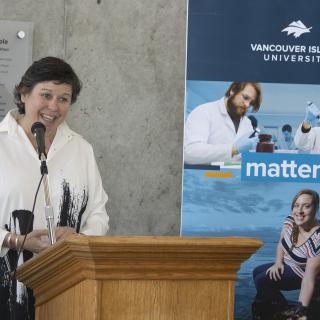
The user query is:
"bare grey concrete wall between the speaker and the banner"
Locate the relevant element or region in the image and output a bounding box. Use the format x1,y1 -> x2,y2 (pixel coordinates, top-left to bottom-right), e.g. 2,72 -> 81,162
0,0 -> 187,235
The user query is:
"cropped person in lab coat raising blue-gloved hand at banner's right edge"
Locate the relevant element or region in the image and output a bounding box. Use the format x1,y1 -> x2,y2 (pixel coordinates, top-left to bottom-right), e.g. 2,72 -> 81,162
294,102 -> 320,153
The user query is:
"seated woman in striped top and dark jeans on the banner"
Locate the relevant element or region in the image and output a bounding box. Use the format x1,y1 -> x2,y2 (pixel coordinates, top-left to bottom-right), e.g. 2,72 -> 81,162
253,189 -> 320,319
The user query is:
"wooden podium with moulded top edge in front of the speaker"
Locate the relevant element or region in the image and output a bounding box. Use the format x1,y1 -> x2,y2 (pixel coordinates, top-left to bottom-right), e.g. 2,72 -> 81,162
17,235 -> 262,320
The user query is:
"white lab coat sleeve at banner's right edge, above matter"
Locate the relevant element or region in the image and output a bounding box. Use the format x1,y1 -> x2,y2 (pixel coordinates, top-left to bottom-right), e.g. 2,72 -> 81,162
294,124 -> 320,153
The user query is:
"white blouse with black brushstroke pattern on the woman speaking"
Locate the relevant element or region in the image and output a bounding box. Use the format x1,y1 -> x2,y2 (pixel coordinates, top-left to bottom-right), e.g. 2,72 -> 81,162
0,110 -> 109,256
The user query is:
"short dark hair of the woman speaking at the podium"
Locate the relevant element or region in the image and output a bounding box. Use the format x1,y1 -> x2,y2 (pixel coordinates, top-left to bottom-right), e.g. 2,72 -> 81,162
13,57 -> 82,114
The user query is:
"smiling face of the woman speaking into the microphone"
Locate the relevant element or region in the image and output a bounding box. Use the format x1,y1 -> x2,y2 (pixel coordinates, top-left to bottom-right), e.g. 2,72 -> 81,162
21,81 -> 72,135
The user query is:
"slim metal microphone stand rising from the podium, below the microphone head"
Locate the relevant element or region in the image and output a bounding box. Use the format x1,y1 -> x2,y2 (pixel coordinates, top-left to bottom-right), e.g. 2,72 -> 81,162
40,153 -> 56,245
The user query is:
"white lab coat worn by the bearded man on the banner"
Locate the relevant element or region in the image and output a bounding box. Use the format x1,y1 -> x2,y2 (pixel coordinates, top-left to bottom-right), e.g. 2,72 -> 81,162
184,98 -> 253,164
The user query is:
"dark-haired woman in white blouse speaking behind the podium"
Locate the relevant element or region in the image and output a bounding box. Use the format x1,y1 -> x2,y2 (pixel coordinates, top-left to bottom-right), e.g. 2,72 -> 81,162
0,57 -> 108,319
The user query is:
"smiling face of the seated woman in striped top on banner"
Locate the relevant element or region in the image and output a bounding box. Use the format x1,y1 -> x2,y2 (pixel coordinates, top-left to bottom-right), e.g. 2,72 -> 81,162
292,194 -> 316,227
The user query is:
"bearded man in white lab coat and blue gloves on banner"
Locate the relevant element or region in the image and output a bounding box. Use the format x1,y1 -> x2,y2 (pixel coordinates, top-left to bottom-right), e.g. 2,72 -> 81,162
184,82 -> 262,164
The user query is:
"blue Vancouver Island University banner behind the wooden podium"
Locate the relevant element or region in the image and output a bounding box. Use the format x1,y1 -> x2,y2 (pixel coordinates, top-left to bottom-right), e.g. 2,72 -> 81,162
181,0 -> 320,320
